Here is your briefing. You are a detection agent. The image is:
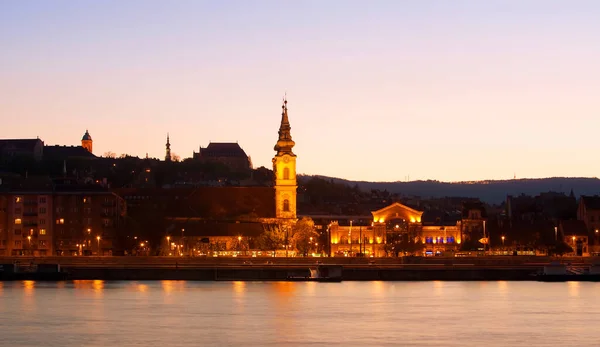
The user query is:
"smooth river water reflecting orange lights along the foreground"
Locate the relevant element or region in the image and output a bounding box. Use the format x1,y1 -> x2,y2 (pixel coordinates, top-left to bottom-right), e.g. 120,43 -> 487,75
0,281 -> 600,346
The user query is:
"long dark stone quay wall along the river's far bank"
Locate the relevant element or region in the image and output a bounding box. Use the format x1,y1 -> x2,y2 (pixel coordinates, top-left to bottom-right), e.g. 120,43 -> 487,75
0,257 -> 595,281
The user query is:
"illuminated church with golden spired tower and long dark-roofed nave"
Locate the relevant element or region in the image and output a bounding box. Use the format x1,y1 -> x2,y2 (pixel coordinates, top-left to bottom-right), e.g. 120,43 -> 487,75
137,99 -> 297,253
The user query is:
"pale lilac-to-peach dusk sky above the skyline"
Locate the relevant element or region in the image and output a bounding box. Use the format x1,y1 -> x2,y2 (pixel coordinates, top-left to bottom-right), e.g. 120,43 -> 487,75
0,0 -> 600,181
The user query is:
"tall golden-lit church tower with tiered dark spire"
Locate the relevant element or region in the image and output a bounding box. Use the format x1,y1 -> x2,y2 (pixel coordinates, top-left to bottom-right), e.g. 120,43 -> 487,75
273,98 -> 298,219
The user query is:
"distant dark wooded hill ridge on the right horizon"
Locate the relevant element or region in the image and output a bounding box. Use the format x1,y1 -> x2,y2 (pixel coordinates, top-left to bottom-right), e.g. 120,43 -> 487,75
300,176 -> 600,204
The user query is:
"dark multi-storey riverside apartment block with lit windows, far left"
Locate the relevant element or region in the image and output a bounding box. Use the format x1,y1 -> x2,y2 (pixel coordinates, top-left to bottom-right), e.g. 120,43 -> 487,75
0,182 -> 125,256
